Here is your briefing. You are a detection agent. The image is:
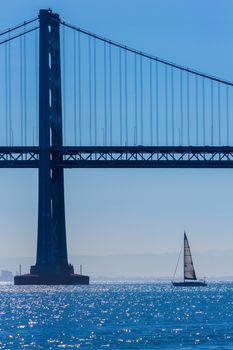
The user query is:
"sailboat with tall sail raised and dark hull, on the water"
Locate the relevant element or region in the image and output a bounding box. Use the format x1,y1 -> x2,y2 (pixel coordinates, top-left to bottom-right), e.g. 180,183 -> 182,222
172,231 -> 207,287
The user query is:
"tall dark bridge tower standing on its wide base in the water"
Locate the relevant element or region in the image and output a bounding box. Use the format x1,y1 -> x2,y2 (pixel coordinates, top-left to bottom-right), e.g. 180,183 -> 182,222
15,10 -> 89,285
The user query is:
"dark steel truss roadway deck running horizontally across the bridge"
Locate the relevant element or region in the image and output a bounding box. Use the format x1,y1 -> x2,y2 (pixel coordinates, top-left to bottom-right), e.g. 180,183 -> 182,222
0,146 -> 233,168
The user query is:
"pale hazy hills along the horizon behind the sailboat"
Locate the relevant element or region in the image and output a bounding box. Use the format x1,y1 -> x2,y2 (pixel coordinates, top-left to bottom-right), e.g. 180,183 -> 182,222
0,250 -> 233,279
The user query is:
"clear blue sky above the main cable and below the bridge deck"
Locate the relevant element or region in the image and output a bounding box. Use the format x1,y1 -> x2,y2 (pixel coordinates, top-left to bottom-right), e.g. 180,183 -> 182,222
0,0 -> 233,275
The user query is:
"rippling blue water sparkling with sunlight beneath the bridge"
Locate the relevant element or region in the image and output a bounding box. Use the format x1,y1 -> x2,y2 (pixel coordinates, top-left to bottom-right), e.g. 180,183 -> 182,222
0,282 -> 233,350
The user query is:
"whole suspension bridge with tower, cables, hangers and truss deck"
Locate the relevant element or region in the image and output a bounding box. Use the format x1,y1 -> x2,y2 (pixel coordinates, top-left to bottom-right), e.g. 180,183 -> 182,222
0,10 -> 233,284
